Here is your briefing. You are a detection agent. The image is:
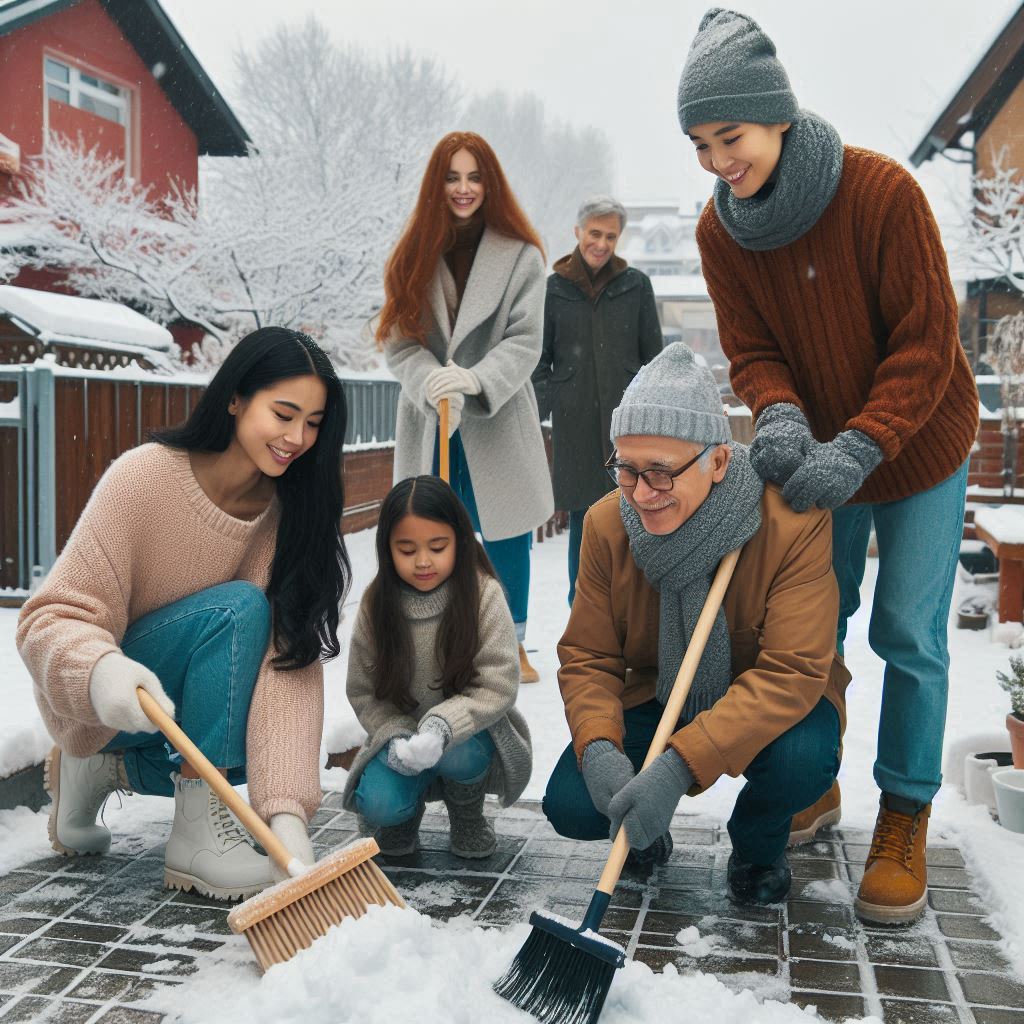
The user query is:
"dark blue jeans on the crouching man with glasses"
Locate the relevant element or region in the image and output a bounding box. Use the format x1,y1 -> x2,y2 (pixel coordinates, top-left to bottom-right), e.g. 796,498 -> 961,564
542,697 -> 840,864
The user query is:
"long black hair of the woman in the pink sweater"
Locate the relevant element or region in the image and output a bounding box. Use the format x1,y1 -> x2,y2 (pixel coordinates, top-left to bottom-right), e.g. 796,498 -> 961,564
150,327 -> 352,669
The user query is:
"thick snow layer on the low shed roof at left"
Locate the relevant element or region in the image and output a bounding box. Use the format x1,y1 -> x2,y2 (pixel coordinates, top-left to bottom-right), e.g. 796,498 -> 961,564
0,285 -> 174,352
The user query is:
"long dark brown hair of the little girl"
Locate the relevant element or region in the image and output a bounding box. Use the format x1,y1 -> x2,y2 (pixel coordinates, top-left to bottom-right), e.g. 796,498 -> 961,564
367,476 -> 495,713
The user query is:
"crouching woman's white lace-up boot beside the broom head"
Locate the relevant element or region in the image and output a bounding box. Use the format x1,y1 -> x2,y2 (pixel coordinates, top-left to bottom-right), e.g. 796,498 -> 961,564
164,775 -> 272,899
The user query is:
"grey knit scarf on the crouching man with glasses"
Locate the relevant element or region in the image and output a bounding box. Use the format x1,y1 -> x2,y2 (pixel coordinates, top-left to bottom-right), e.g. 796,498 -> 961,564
618,443 -> 764,724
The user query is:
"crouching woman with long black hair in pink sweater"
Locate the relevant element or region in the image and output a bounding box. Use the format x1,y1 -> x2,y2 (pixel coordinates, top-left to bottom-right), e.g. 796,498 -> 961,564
17,327 -> 351,899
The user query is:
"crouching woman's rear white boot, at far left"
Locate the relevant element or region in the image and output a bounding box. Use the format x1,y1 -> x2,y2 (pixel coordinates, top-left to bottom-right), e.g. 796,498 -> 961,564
43,746 -> 131,857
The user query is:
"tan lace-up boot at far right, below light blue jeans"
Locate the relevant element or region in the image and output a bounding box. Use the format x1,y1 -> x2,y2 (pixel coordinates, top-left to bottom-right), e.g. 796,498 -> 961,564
854,795 -> 932,925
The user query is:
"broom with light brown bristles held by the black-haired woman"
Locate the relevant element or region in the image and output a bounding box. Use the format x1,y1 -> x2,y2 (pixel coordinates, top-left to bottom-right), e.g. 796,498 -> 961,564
135,687 -> 406,971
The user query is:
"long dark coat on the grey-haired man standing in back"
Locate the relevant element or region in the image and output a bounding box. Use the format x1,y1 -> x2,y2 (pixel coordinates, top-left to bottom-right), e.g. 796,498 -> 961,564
534,260 -> 662,512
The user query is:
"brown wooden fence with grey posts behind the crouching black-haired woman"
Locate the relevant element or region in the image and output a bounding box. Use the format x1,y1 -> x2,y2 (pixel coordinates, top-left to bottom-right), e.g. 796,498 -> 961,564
0,359 -> 399,598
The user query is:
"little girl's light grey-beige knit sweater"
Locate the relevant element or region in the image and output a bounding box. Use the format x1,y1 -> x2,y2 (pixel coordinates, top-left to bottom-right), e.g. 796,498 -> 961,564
344,575 -> 532,810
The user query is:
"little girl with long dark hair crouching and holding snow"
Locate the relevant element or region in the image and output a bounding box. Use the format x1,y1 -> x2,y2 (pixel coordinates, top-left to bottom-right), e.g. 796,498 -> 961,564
344,476 -> 532,858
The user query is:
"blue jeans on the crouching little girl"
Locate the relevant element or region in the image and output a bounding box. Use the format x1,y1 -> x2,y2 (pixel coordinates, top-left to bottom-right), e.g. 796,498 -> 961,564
355,730 -> 495,827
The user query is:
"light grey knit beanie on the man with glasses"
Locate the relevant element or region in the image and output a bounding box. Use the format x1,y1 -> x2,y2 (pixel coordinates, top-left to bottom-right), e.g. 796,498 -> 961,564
611,341 -> 731,444
